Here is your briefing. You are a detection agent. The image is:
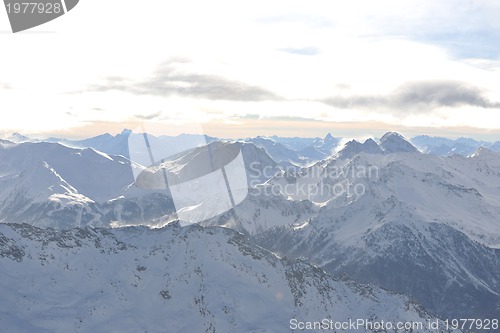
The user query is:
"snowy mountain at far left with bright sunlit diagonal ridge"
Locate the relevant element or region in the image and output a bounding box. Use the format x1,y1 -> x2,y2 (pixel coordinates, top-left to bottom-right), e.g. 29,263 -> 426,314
0,143 -> 125,225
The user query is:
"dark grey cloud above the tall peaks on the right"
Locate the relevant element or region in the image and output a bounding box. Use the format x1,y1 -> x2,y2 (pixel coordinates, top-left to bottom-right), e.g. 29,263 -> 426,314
322,81 -> 500,111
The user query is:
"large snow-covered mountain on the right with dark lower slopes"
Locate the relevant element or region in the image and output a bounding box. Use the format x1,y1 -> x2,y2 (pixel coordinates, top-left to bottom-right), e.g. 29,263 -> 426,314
255,136 -> 500,318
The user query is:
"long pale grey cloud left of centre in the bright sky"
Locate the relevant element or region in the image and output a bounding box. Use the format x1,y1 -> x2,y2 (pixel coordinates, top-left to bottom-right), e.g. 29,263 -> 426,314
89,60 -> 281,101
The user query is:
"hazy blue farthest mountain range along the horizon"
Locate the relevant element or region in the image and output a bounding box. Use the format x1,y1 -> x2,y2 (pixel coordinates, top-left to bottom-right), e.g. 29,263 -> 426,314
7,129 -> 500,160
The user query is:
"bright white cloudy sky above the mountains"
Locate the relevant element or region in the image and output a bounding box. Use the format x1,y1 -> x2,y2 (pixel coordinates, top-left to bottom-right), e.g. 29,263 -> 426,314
0,0 -> 500,141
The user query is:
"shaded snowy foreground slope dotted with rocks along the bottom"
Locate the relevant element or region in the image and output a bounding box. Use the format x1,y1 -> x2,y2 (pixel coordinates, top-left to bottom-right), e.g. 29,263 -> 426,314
0,220 -> 458,333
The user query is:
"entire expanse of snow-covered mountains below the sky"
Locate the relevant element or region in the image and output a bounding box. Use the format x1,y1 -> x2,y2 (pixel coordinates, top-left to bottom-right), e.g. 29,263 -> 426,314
0,131 -> 500,332
